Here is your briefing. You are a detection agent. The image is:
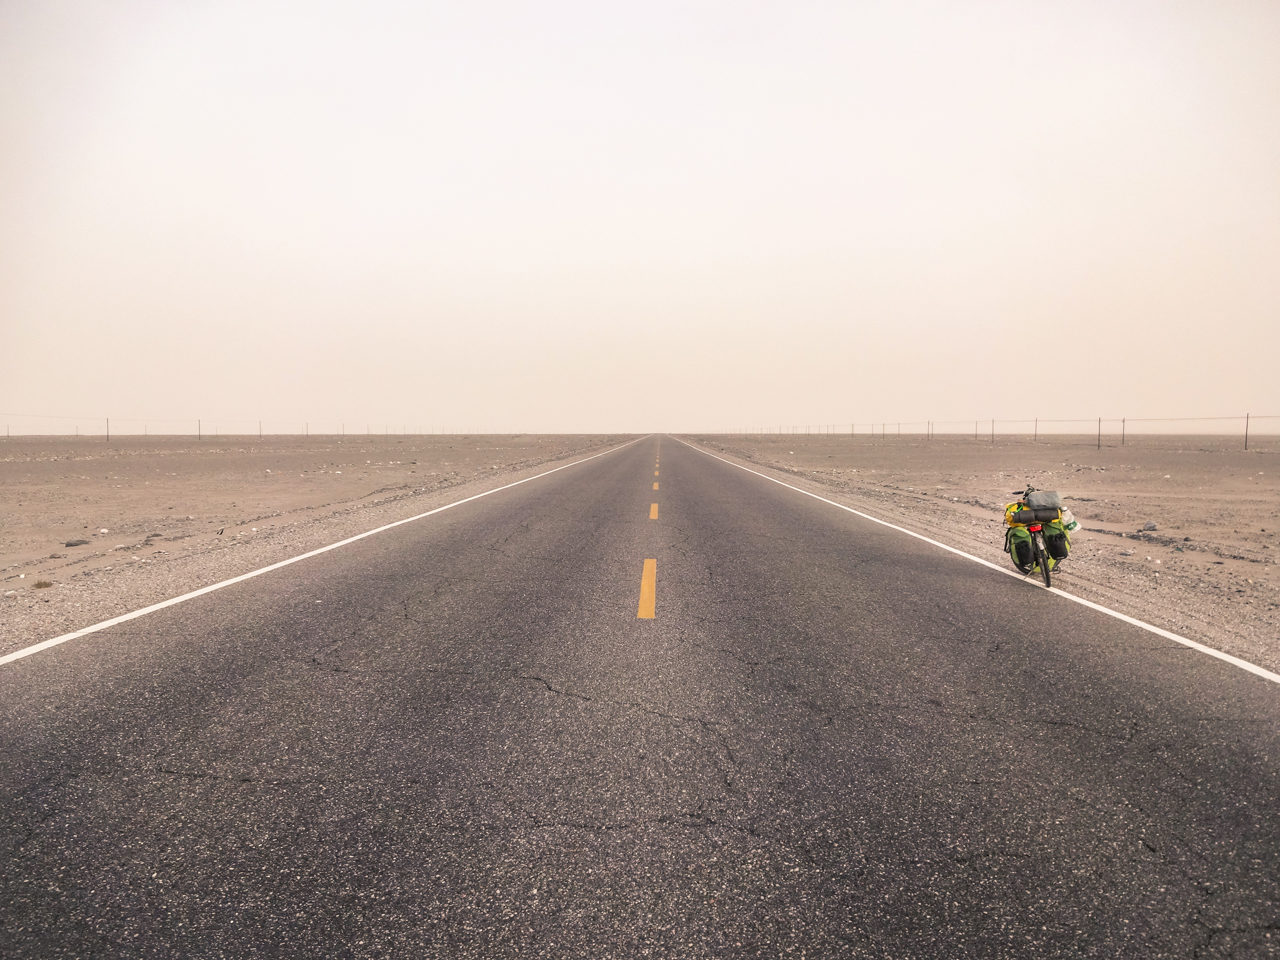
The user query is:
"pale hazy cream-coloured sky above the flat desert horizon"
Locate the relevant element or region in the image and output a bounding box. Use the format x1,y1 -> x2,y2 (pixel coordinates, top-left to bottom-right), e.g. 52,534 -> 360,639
0,0 -> 1280,431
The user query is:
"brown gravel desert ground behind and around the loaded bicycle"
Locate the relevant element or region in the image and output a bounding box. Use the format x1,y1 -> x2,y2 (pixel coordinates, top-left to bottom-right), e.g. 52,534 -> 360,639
685,434 -> 1280,672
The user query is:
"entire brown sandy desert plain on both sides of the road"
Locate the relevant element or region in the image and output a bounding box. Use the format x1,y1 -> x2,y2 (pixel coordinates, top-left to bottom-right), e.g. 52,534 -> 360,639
0,434 -> 1280,671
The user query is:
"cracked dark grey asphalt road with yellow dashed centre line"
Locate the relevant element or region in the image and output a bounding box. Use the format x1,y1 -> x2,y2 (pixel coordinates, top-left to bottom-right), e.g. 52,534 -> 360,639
0,438 -> 1280,957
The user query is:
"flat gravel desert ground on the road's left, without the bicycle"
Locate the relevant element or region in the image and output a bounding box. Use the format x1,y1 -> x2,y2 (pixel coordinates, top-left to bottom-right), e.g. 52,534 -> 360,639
0,435 -> 630,655
